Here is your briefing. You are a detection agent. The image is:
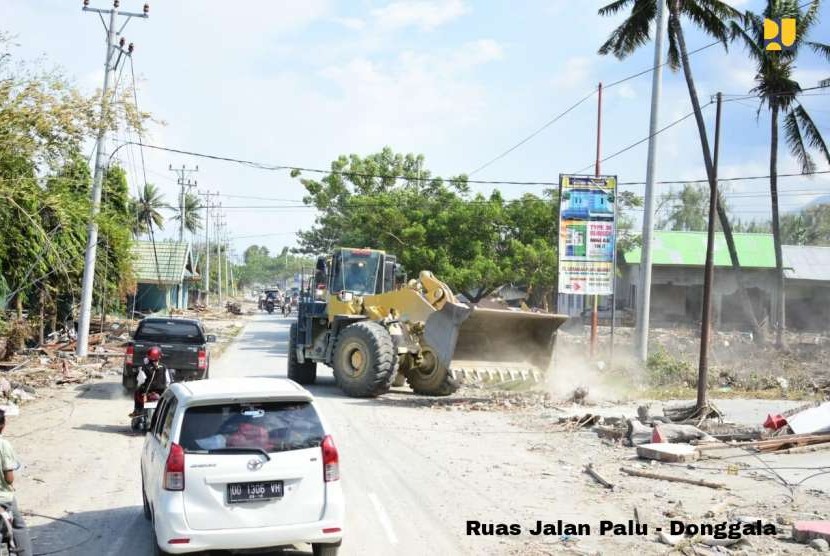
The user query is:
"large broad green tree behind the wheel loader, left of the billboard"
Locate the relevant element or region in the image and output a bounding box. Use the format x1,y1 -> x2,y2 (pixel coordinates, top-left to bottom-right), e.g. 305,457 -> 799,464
298,147 -> 556,302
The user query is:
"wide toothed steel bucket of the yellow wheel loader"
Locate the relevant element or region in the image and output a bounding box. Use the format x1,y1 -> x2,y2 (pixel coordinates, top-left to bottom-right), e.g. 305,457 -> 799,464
451,308 -> 568,379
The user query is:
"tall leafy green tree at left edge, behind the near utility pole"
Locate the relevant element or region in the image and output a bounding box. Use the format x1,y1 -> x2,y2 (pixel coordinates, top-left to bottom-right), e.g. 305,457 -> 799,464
0,38 -> 146,329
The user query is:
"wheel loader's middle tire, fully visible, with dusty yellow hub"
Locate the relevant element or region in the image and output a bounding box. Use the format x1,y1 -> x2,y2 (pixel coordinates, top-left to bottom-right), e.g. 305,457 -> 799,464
332,321 -> 397,398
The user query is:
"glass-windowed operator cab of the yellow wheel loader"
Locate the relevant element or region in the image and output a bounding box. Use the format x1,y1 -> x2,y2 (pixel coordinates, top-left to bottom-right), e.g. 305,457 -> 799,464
328,248 -> 397,295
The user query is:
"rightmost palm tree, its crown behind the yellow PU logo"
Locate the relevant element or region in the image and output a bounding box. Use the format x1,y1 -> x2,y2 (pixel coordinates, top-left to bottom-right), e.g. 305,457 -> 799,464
741,0 -> 830,347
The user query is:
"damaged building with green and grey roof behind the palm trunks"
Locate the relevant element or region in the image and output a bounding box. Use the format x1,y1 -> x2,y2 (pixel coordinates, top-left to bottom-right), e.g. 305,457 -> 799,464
616,231 -> 830,331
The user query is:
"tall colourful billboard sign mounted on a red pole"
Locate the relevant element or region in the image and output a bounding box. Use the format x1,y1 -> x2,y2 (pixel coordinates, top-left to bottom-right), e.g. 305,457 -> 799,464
559,174 -> 617,295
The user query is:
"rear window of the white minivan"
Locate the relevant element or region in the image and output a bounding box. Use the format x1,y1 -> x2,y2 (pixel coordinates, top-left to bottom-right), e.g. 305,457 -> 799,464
179,402 -> 324,453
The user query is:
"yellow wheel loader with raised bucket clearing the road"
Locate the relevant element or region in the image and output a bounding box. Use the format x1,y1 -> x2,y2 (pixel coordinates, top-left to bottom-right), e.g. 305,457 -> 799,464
288,248 -> 567,397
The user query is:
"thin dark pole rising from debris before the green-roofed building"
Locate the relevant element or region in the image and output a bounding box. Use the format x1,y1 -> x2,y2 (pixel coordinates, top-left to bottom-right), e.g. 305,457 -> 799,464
696,93 -> 723,415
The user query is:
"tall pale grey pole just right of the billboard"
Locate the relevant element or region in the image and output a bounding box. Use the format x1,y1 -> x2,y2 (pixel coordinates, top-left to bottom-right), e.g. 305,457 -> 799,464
635,1 -> 667,361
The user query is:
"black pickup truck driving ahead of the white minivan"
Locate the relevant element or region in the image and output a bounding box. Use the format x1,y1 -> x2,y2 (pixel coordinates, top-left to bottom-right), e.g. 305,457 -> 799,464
121,317 -> 216,391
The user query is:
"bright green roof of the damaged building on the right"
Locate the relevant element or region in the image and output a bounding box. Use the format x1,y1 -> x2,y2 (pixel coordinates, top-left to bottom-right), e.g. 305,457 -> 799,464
623,231 -> 775,268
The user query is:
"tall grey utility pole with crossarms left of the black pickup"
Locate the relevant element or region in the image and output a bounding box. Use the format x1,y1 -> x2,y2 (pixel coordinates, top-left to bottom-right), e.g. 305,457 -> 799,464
75,0 -> 150,357
